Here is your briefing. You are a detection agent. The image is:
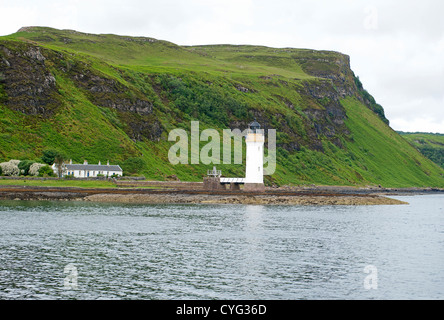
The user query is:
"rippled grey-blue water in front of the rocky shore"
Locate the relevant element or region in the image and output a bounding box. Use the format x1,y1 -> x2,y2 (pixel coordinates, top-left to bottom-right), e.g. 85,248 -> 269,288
0,195 -> 444,299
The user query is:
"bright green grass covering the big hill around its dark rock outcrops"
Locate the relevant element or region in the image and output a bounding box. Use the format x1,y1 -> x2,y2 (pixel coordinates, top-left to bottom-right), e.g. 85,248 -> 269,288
0,28 -> 444,187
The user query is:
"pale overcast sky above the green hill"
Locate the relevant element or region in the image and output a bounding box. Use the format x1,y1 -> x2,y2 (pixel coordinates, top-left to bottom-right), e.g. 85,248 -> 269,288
0,0 -> 444,133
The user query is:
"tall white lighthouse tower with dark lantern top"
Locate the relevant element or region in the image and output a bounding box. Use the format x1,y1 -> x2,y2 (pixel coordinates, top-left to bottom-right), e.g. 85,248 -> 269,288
244,120 -> 265,191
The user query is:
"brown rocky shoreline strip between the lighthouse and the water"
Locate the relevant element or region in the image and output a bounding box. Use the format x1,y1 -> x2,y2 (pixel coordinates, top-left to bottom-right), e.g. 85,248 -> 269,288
0,186 -> 424,205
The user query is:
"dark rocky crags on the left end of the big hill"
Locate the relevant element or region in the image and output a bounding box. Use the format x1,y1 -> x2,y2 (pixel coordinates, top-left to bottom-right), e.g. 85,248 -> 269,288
0,41 -> 163,141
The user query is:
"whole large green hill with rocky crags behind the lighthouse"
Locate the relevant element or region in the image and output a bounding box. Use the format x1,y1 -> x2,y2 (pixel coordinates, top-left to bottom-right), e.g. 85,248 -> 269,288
0,27 -> 444,187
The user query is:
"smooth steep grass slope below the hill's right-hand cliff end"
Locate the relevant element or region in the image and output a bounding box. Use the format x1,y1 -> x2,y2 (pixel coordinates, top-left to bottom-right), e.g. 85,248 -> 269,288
343,99 -> 443,187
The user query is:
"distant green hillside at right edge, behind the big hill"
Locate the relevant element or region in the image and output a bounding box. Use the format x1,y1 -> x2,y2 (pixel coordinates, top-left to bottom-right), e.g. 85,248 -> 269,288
398,132 -> 444,168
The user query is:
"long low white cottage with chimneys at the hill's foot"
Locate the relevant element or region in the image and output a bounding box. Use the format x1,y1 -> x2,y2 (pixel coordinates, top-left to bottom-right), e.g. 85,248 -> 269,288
52,160 -> 123,178
